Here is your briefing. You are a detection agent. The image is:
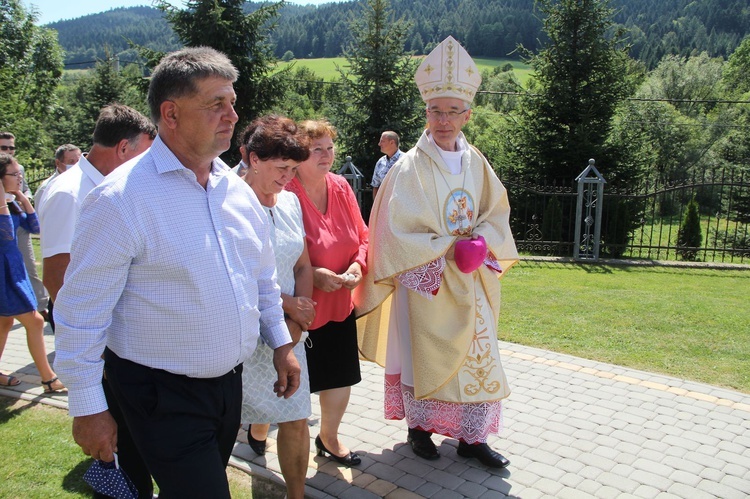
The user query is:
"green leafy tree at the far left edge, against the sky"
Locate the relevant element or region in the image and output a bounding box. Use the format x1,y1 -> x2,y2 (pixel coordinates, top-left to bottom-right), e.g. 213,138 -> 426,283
0,0 -> 62,167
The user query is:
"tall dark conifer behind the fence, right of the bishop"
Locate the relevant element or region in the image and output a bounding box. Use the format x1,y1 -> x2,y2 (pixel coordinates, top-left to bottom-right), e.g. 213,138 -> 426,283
514,0 -> 633,182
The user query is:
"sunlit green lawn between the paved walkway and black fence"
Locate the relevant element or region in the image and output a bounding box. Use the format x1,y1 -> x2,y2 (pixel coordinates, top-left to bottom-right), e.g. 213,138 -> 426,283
498,261 -> 750,393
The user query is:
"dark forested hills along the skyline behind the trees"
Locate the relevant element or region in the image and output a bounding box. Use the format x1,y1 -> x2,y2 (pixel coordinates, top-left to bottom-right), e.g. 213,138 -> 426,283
49,0 -> 750,68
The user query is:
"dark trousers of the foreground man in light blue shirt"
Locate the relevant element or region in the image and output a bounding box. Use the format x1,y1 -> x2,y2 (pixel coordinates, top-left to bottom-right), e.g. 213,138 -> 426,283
104,349 -> 242,499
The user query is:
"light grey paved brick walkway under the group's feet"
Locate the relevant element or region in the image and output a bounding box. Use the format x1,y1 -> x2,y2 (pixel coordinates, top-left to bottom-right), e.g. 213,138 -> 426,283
0,325 -> 750,499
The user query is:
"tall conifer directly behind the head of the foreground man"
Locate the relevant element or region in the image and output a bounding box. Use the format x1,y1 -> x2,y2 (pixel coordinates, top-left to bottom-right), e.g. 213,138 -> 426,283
156,0 -> 288,161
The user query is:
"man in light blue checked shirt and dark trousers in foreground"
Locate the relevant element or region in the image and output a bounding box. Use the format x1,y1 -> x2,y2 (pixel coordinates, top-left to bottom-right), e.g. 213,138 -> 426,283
55,47 -> 300,498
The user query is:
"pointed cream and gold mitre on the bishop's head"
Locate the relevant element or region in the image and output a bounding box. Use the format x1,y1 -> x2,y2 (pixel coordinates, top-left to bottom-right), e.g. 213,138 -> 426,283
414,36 -> 482,103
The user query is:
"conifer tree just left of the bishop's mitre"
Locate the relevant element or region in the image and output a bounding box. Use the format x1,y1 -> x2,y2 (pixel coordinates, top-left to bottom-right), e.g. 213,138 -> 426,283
332,0 -> 422,179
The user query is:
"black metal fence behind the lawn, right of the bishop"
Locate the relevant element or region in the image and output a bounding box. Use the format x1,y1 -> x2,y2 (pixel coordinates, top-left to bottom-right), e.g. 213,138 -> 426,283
503,167 -> 750,263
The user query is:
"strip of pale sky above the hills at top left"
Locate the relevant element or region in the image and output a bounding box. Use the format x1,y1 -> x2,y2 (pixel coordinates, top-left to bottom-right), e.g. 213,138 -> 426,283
23,0 -> 340,24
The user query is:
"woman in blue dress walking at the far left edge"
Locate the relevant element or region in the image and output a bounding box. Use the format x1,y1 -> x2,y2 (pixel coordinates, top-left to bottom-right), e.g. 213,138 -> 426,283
0,154 -> 65,393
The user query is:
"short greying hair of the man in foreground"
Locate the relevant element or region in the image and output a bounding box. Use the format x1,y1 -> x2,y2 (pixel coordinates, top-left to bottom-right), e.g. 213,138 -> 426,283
148,47 -> 239,124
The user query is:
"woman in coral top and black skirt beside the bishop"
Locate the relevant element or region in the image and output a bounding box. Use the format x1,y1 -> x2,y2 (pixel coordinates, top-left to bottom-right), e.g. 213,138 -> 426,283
286,121 -> 368,466
